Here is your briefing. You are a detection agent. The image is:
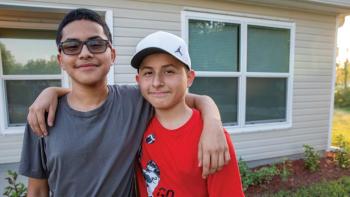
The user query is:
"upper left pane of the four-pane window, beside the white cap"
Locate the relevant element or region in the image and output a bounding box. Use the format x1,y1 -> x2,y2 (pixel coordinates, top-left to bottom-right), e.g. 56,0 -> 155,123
189,19 -> 239,72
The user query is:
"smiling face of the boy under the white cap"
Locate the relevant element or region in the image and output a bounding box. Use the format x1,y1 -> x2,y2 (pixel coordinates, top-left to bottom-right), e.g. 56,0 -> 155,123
136,53 -> 194,110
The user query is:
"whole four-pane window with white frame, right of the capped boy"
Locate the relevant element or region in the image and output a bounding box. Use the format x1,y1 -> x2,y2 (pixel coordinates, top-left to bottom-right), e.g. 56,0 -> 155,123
183,11 -> 294,131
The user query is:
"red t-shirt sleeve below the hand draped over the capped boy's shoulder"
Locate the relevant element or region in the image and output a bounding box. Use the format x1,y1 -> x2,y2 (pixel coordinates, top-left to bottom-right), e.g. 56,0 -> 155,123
207,132 -> 244,197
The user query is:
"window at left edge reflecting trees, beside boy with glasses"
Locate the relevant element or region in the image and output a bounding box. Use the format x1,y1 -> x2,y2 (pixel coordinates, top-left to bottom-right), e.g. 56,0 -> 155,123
0,28 -> 62,132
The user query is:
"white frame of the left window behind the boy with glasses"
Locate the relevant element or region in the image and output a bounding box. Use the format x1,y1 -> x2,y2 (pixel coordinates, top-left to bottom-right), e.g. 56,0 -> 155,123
0,3 -> 115,135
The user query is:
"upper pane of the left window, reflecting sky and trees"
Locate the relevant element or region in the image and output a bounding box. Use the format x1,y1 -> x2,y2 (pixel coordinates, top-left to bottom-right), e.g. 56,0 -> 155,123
0,28 -> 61,75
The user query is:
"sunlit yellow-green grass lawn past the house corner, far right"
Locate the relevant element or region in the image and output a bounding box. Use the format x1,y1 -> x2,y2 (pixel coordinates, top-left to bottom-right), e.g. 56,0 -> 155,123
332,108 -> 350,145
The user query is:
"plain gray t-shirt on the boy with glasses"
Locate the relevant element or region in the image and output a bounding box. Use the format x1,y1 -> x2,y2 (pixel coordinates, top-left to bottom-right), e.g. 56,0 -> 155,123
19,86 -> 153,197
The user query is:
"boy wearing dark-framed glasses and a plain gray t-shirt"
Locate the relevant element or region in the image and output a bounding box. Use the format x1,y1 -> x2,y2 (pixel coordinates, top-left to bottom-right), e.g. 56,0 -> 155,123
19,9 -> 227,197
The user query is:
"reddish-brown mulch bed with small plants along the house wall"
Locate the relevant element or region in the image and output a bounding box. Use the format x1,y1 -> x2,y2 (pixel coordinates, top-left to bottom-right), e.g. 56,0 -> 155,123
245,153 -> 350,197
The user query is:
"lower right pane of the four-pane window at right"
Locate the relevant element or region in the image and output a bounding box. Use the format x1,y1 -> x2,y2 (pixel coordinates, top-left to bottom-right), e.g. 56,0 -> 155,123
246,78 -> 287,124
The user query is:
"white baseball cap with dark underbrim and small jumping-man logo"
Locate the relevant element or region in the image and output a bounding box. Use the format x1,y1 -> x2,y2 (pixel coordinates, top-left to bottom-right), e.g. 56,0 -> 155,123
131,31 -> 191,69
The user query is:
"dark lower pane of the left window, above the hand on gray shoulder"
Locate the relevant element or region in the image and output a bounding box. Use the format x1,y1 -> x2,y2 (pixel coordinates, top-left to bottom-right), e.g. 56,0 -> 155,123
5,80 -> 61,126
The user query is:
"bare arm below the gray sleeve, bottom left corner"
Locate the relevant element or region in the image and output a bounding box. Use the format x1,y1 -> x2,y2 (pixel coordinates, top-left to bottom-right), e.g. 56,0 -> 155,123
27,178 -> 49,197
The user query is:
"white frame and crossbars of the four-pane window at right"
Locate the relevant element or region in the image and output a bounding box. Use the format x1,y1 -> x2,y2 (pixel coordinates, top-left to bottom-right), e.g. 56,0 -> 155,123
181,11 -> 295,133
